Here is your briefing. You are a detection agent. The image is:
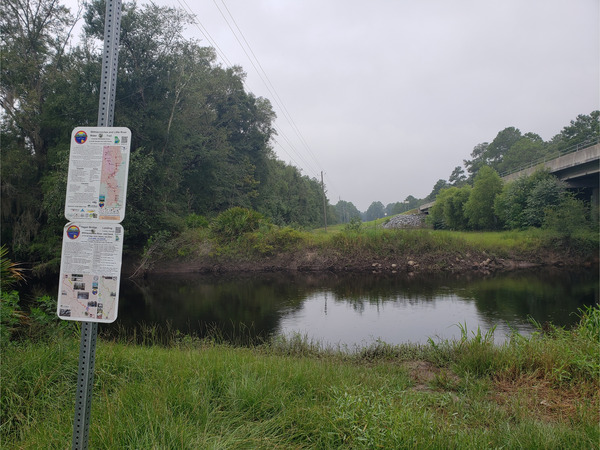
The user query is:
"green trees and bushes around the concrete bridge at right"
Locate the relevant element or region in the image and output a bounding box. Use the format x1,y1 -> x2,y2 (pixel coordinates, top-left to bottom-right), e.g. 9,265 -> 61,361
363,111 -> 600,225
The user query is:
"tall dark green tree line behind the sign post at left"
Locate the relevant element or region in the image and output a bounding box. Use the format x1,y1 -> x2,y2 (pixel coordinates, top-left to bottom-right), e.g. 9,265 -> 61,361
0,0 -> 335,261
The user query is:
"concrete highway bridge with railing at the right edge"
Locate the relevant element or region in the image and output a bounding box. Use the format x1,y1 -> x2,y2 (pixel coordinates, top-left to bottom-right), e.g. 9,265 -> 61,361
419,139 -> 600,214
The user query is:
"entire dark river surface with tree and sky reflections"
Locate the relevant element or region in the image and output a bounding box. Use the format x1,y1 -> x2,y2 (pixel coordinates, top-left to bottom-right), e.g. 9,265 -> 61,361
107,270 -> 598,348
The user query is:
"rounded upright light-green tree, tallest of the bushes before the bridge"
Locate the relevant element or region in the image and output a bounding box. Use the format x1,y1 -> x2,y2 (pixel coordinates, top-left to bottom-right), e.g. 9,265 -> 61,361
464,166 -> 502,230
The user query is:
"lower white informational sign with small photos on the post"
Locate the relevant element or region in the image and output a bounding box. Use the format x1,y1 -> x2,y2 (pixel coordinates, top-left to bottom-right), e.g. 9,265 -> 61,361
56,222 -> 123,323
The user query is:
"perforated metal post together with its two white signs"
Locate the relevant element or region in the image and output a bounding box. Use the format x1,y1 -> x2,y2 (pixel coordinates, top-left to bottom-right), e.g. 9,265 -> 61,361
56,0 -> 126,449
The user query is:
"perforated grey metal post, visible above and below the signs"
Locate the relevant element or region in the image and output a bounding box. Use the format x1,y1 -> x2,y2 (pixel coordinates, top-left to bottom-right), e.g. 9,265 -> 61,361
72,0 -> 121,449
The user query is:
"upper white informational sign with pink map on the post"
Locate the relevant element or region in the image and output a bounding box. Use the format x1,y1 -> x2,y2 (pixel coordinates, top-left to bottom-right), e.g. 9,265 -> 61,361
65,127 -> 131,223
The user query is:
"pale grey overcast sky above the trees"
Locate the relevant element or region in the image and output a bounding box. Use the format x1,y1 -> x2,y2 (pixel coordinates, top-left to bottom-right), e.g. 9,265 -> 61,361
69,0 -> 600,211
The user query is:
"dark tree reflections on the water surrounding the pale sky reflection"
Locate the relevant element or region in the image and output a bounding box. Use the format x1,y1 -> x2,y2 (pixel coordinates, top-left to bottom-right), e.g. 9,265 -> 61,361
112,270 -> 598,342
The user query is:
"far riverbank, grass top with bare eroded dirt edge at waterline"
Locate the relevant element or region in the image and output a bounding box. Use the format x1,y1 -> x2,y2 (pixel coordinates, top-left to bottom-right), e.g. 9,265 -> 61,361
129,227 -> 598,277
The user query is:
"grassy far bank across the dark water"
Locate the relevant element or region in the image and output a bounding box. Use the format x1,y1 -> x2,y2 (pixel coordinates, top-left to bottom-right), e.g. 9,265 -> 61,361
142,216 -> 600,274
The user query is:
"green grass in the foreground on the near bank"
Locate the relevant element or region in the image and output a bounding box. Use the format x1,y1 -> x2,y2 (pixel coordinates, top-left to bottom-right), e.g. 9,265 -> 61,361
0,307 -> 600,449
